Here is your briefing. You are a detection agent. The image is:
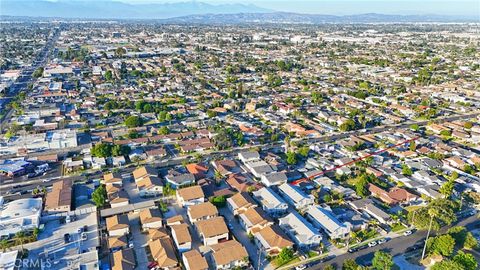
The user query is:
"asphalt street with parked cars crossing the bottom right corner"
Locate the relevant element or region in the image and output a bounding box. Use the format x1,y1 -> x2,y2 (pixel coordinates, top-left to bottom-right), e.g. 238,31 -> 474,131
308,216 -> 480,270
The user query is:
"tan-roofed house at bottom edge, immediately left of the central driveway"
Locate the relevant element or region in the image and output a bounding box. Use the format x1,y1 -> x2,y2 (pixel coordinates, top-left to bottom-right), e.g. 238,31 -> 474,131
210,240 -> 248,270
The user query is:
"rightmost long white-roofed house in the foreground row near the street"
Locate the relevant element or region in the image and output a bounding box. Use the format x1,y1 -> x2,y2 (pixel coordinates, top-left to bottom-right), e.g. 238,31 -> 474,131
307,205 -> 352,239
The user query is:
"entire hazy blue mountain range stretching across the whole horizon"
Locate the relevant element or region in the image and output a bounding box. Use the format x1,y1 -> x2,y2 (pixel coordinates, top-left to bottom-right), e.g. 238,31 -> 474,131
0,0 -> 479,24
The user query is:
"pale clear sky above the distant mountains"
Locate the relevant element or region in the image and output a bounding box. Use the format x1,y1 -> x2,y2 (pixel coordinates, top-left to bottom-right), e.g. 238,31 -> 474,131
116,0 -> 480,16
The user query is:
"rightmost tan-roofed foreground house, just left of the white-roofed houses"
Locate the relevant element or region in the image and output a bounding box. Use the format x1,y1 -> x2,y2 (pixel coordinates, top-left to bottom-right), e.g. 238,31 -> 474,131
254,224 -> 293,256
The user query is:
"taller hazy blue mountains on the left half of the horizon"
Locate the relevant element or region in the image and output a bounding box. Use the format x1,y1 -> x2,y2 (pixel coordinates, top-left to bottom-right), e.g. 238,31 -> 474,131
0,0 -> 272,19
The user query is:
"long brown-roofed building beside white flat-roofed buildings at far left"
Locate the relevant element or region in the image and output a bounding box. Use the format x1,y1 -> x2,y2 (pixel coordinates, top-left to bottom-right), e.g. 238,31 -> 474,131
44,179 -> 72,214
